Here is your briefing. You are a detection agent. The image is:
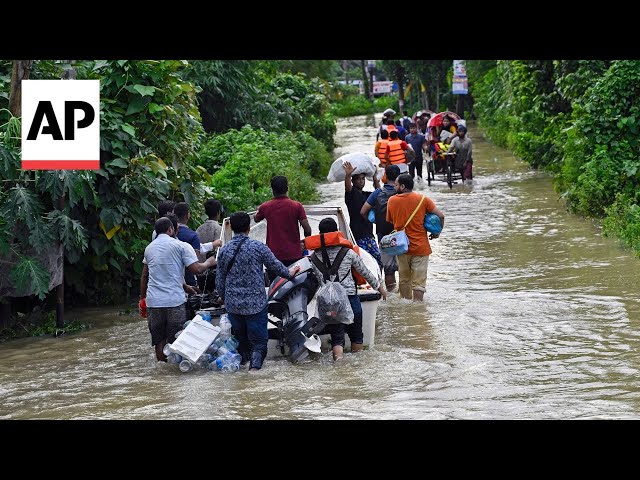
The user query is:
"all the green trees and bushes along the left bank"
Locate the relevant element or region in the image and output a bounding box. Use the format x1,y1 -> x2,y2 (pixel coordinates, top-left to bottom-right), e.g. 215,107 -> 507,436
0,60 -> 337,316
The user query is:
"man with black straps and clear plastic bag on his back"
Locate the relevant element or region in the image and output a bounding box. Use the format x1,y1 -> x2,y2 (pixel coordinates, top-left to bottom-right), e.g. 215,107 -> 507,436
311,218 -> 387,360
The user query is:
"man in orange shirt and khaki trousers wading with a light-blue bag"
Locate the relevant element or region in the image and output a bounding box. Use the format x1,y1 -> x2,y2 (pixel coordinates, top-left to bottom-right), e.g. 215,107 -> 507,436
387,174 -> 444,302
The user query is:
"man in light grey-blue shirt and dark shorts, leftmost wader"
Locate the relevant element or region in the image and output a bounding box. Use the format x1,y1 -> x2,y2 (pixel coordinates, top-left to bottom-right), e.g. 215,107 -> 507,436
140,217 -> 216,362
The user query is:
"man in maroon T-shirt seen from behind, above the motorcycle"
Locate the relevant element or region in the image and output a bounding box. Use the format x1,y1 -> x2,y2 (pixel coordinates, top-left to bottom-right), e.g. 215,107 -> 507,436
253,175 -> 311,280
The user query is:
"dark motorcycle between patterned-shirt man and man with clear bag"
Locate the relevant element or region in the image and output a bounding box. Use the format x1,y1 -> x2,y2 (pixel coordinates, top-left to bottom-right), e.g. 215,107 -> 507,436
268,257 -> 325,362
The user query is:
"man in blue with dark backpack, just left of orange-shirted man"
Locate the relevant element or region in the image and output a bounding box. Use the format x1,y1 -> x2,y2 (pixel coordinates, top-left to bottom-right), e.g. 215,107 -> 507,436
360,165 -> 400,292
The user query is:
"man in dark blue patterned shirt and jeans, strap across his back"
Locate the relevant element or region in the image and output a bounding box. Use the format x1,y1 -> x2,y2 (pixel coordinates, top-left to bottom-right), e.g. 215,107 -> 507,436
216,212 -> 295,370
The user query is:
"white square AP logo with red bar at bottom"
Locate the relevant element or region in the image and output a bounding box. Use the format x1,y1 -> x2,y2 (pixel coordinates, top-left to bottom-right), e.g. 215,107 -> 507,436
22,80 -> 100,170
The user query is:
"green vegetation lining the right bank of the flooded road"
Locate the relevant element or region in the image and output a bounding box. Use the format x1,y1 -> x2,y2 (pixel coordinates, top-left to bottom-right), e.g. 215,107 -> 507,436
468,60 -> 640,256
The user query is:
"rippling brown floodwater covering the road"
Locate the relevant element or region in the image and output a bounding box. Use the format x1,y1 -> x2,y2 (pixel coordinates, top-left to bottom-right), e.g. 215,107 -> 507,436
0,117 -> 640,419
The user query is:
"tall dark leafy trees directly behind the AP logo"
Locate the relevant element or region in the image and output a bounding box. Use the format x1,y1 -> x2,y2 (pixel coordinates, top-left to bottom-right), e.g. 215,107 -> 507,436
0,60 -> 209,302
